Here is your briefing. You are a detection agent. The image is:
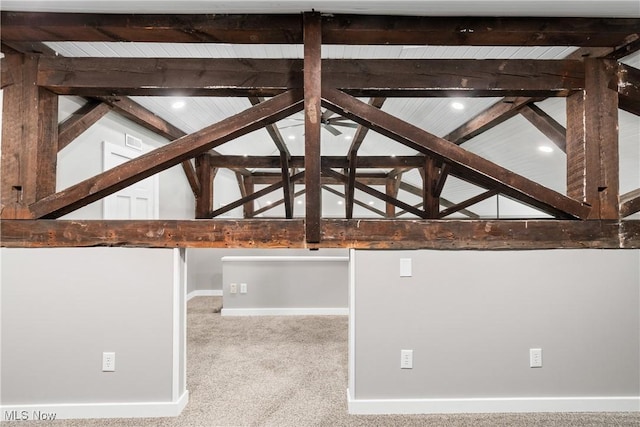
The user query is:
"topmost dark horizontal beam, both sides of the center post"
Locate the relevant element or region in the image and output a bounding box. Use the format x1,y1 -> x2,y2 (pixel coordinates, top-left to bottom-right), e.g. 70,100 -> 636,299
1,11 -> 640,47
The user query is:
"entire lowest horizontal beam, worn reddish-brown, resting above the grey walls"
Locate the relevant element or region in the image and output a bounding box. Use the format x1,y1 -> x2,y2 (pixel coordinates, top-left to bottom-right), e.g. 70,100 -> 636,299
0,219 -> 640,250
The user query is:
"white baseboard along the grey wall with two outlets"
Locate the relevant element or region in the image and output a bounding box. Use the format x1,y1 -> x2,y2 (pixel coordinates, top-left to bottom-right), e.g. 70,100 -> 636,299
347,390 -> 640,415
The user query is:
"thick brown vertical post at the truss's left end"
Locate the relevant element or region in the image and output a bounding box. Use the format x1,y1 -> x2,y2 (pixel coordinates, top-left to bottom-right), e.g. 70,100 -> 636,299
0,54 -> 58,219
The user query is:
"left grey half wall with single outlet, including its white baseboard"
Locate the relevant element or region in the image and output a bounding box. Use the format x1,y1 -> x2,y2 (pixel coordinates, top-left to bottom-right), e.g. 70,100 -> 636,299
0,248 -> 186,419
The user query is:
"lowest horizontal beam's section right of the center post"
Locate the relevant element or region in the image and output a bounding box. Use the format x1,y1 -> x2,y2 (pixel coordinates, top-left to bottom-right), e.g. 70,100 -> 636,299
322,219 -> 640,250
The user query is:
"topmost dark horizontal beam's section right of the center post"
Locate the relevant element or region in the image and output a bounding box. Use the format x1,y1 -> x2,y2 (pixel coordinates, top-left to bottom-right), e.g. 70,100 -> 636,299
323,15 -> 640,47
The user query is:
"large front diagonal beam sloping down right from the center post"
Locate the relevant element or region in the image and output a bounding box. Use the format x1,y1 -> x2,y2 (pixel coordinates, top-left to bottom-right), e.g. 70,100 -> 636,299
323,89 -> 590,218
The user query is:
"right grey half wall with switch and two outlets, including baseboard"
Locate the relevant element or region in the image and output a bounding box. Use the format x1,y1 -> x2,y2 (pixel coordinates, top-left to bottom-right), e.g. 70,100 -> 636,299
349,250 -> 640,413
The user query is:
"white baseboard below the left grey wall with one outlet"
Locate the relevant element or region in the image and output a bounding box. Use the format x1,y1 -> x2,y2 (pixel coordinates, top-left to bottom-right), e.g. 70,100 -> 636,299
0,391 -> 189,421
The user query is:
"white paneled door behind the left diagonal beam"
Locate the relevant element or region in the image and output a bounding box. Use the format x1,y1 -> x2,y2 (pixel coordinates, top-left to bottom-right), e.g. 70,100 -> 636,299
103,141 -> 159,219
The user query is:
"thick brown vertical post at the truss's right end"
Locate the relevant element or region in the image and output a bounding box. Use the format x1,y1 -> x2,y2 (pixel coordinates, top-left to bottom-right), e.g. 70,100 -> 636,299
567,58 -> 619,219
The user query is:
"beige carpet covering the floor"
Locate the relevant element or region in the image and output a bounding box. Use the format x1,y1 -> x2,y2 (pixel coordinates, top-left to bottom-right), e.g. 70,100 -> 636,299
12,297 -> 640,427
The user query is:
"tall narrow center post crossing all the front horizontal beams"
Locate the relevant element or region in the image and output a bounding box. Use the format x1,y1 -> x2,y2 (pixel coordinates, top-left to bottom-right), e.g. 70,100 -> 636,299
303,12 -> 322,243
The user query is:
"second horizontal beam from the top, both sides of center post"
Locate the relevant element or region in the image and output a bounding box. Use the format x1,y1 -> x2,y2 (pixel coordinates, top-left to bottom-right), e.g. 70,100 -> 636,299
38,57 -> 584,96
